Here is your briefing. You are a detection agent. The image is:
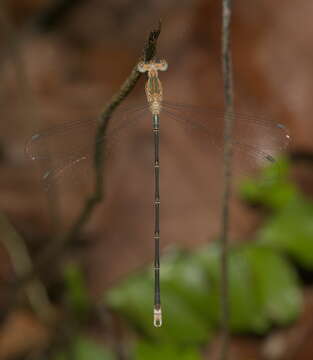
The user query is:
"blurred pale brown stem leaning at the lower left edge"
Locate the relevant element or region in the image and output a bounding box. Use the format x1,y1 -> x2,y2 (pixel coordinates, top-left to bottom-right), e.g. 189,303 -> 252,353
0,213 -> 55,322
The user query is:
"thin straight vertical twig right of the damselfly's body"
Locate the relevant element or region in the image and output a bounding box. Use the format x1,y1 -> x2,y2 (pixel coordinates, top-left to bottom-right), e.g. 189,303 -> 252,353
220,0 -> 234,360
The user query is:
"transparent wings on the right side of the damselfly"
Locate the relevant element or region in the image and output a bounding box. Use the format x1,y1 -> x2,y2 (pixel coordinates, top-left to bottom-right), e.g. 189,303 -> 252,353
161,102 -> 290,179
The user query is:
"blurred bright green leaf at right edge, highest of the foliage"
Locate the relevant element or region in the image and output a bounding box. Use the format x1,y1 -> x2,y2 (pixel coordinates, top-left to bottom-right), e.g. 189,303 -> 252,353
241,160 -> 313,270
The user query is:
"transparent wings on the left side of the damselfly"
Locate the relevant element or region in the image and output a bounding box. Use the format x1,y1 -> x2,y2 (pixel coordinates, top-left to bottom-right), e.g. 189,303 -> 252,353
25,105 -> 147,188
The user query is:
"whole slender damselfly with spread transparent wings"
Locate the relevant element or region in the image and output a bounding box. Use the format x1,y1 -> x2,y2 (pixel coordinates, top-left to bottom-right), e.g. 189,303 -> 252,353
26,60 -> 290,327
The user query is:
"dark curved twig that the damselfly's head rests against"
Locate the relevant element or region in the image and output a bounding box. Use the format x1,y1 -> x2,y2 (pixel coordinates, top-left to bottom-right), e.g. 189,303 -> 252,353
13,22 -> 161,288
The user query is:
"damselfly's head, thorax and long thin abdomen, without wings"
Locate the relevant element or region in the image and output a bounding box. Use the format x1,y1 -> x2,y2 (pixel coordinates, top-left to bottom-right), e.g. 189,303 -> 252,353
137,60 -> 167,327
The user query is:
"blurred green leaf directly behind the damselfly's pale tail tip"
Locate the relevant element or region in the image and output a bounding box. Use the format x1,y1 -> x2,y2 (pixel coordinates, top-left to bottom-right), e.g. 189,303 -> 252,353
105,256 -> 210,344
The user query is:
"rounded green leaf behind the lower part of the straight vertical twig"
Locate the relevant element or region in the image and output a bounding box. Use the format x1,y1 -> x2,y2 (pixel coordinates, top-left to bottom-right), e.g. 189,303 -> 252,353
198,244 -> 301,334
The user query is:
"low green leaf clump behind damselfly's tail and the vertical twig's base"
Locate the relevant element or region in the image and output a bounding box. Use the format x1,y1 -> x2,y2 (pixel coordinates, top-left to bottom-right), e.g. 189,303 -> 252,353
106,244 -> 301,345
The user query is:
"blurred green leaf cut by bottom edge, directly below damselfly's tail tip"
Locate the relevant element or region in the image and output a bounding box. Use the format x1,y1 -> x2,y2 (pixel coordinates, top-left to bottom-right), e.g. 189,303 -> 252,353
134,342 -> 202,360
